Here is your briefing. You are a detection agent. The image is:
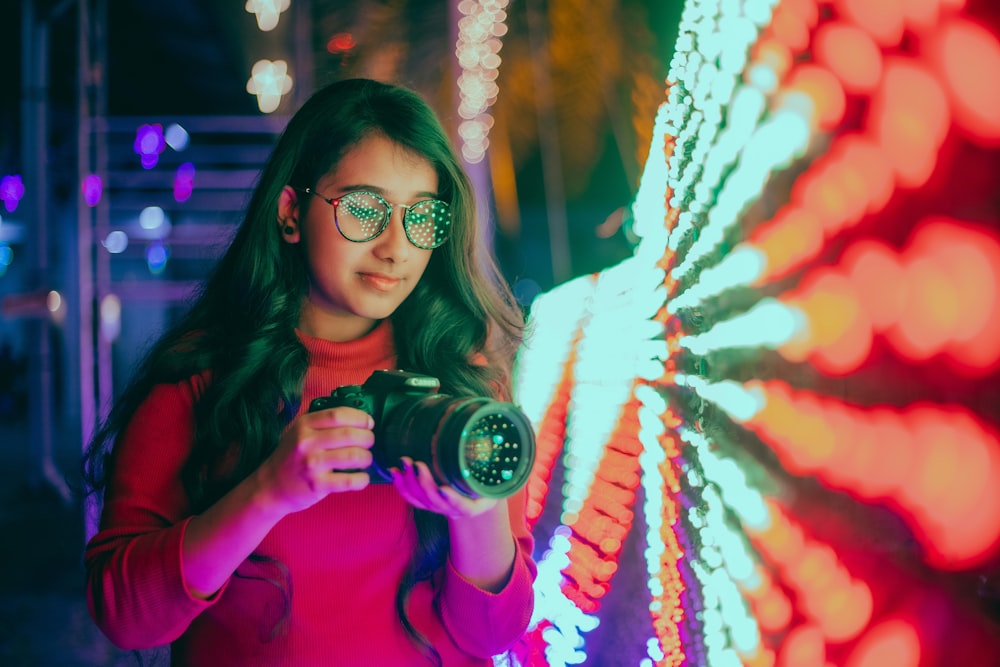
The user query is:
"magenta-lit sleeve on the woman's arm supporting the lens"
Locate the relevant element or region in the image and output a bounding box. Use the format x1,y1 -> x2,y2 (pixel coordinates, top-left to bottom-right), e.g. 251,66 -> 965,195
441,488 -> 536,658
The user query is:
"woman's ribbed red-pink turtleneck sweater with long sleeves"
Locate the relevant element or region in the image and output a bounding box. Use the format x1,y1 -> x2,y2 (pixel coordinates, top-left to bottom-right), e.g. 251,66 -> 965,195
84,323 -> 535,667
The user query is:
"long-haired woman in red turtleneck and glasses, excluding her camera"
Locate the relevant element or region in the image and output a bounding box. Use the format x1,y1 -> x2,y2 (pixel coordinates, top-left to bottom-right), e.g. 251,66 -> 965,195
85,80 -> 535,667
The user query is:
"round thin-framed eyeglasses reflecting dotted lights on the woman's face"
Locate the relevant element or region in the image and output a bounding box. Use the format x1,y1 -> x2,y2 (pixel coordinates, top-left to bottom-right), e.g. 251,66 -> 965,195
295,188 -> 451,250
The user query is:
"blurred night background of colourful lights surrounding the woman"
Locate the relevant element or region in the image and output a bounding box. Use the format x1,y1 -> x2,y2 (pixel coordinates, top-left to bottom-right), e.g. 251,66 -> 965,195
0,0 -> 1000,667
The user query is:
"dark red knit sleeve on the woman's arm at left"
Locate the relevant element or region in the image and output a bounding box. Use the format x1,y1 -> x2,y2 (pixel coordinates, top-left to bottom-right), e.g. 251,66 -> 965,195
84,382 -> 225,649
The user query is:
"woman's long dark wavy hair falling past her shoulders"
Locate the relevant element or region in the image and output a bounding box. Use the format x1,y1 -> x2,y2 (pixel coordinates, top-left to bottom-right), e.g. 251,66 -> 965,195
83,79 -> 523,661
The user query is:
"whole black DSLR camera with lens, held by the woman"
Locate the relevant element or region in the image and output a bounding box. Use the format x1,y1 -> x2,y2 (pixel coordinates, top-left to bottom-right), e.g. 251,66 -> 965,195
309,371 -> 535,498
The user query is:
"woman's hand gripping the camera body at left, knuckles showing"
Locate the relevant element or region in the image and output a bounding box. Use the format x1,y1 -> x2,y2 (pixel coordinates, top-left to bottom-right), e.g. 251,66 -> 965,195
256,407 -> 375,514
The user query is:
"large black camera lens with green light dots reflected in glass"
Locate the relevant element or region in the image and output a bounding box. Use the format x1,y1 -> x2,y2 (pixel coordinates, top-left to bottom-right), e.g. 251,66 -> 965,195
383,394 -> 535,498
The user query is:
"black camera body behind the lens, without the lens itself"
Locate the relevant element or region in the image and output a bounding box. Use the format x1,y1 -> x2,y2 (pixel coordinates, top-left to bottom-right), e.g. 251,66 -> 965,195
309,370 -> 441,484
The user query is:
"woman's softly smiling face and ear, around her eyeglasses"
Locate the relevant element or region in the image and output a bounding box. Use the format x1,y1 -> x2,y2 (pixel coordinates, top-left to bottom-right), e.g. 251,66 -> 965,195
278,134 -> 438,341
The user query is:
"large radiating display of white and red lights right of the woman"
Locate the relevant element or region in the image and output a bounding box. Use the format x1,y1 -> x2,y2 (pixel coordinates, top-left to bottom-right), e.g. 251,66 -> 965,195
515,0 -> 1000,667
